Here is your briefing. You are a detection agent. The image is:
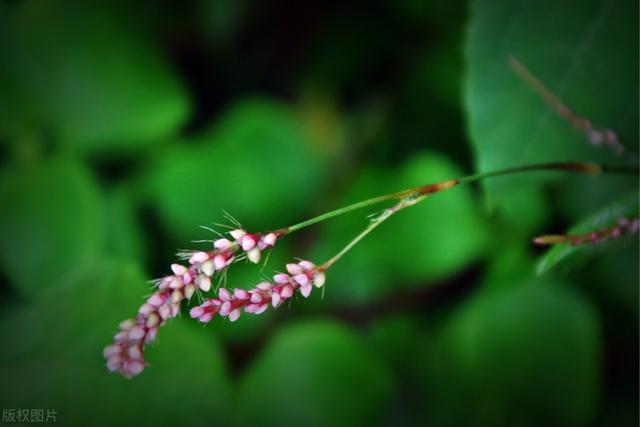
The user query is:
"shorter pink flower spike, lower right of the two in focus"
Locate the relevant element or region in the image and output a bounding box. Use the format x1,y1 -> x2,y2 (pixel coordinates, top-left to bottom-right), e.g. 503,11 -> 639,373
190,261 -> 325,323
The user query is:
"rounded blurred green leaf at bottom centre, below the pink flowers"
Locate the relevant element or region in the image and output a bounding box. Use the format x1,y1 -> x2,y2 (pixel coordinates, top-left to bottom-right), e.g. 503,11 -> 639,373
236,321 -> 393,427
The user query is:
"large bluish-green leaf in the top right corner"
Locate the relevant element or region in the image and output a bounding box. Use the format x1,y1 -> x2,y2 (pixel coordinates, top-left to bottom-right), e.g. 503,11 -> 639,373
466,0 -> 639,215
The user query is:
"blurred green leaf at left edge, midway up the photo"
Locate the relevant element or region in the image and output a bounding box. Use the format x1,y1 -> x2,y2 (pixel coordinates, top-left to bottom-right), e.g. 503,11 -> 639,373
0,157 -> 104,296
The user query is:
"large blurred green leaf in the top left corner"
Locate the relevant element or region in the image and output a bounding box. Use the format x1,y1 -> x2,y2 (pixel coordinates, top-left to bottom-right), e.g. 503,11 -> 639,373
0,0 -> 189,150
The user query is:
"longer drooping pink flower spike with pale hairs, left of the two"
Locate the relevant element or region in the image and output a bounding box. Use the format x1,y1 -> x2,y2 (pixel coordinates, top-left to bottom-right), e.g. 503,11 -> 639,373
103,229 -> 279,378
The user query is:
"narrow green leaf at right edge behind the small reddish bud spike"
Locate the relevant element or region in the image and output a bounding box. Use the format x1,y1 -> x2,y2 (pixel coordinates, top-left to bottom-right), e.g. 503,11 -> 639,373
536,190 -> 640,274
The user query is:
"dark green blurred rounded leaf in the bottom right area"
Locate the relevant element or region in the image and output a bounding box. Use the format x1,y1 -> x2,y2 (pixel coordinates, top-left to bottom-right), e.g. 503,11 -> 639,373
424,282 -> 600,426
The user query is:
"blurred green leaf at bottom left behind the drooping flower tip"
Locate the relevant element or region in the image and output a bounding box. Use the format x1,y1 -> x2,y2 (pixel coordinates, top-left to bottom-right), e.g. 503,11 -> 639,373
0,261 -> 229,426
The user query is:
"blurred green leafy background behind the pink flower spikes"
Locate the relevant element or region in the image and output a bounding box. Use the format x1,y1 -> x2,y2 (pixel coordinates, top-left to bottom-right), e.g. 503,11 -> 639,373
0,0 -> 638,427
